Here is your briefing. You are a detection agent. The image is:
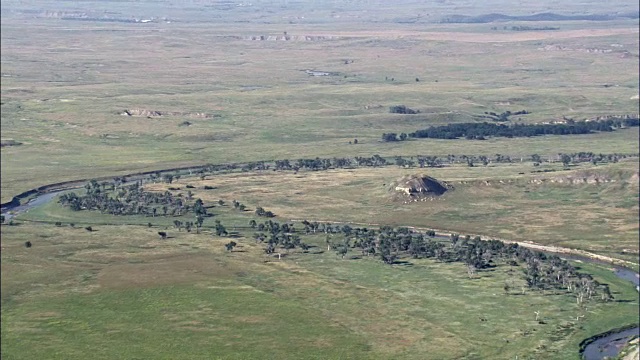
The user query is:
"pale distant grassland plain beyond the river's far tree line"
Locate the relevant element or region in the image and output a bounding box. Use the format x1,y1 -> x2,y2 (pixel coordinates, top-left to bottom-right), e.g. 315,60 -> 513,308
0,11 -> 639,202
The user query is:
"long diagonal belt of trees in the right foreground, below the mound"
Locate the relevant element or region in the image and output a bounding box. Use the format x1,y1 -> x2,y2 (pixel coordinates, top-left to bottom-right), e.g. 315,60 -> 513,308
302,220 -> 613,304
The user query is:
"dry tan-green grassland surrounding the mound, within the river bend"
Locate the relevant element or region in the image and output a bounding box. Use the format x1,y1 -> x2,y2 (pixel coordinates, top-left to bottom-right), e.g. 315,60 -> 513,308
13,158 -> 639,264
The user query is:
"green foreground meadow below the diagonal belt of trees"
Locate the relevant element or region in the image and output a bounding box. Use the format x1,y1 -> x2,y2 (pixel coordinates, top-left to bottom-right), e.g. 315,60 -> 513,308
2,219 -> 638,359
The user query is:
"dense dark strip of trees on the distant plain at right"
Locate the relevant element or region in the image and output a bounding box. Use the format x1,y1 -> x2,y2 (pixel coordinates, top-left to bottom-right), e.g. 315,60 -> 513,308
382,119 -> 640,141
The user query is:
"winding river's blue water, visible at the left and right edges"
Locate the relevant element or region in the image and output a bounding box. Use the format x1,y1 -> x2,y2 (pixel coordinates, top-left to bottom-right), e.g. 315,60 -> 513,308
2,185 -> 640,360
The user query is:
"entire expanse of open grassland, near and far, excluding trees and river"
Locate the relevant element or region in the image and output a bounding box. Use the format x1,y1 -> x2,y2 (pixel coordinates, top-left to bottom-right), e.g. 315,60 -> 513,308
0,0 -> 640,360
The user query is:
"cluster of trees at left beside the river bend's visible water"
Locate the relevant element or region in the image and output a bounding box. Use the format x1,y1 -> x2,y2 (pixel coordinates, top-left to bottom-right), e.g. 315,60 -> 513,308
58,180 -> 208,218
